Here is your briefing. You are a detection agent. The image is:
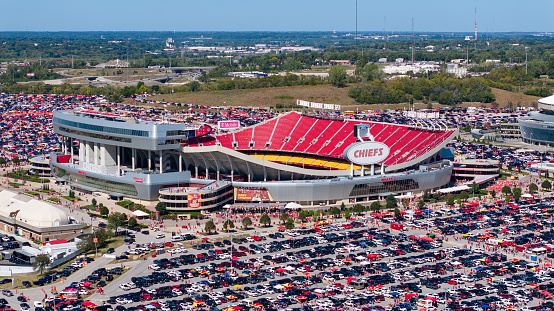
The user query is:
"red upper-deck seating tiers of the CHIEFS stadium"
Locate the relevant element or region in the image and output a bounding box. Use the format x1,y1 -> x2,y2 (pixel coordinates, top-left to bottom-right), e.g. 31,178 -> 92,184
189,112 -> 455,166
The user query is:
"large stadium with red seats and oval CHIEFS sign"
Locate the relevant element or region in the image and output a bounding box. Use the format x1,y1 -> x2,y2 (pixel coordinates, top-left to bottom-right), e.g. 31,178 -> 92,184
50,105 -> 458,211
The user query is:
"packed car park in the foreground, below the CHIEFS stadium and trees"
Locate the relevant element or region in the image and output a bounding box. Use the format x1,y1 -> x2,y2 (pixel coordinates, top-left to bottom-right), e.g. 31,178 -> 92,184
3,196 -> 540,311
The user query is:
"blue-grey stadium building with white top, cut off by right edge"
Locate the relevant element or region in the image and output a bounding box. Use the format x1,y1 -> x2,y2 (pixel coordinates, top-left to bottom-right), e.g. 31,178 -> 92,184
518,95 -> 554,147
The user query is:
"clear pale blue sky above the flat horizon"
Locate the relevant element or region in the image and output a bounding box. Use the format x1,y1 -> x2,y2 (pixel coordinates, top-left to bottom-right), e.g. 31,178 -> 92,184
0,0 -> 554,33
